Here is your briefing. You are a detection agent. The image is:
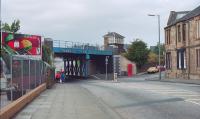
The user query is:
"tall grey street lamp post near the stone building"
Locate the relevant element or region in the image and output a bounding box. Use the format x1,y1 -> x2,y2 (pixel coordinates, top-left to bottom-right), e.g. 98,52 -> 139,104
148,14 -> 161,80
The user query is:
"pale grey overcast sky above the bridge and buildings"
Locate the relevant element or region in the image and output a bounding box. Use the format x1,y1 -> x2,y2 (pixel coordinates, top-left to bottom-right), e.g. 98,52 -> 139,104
1,0 -> 200,46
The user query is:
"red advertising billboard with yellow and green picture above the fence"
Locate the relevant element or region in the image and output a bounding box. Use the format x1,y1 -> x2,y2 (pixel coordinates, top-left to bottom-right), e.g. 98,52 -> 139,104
2,32 -> 42,56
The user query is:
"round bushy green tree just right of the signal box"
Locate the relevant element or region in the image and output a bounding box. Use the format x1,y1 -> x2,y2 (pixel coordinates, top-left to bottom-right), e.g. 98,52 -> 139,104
125,40 -> 149,68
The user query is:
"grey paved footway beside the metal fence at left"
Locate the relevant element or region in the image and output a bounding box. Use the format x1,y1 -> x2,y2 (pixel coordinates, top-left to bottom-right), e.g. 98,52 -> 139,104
14,81 -> 121,119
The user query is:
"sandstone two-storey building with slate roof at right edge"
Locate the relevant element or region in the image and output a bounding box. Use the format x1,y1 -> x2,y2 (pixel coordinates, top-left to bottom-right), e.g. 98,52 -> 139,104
165,6 -> 200,80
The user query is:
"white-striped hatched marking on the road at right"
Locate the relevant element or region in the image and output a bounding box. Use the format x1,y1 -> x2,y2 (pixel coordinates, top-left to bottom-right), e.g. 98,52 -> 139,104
109,83 -> 200,106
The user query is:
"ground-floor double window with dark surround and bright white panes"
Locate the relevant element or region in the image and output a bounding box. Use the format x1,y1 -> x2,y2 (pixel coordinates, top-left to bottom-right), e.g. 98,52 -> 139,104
177,49 -> 187,69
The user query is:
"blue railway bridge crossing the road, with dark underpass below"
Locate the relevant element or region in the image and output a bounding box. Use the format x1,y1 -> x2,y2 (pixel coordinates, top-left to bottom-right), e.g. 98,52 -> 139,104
53,41 -> 113,79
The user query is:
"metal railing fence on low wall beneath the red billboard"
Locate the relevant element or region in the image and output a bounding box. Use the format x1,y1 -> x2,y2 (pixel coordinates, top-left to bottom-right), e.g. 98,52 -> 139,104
0,55 -> 54,108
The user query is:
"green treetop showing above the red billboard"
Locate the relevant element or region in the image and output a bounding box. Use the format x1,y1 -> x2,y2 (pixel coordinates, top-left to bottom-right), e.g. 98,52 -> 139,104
2,20 -> 20,33
